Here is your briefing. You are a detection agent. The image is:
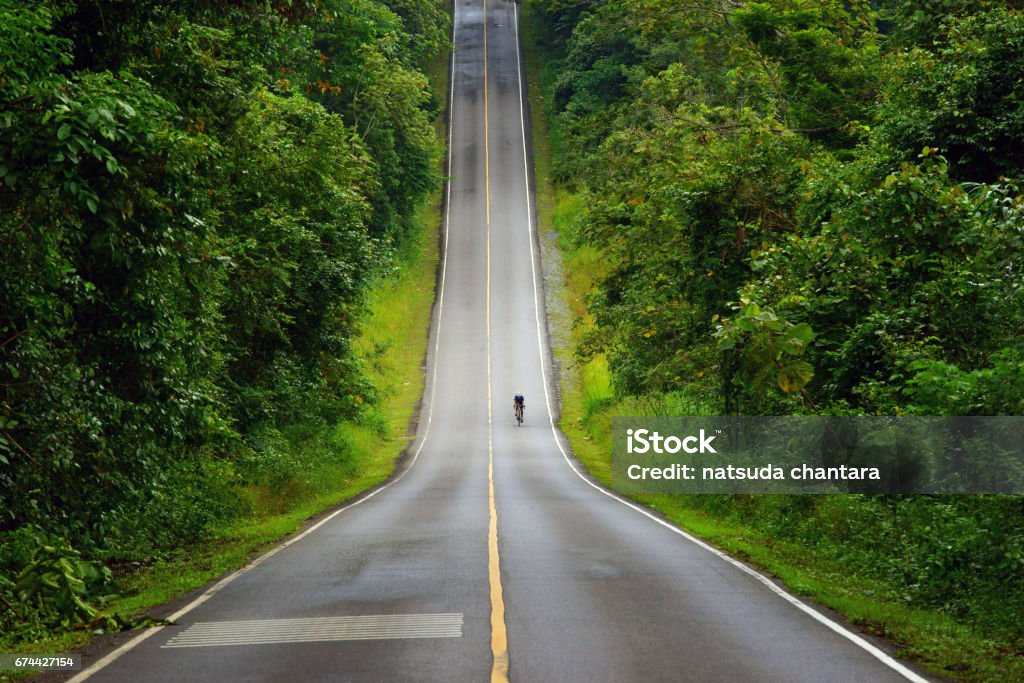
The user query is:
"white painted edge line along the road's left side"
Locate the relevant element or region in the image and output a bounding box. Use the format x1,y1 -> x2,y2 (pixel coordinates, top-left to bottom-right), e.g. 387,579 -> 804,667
68,0 -> 459,683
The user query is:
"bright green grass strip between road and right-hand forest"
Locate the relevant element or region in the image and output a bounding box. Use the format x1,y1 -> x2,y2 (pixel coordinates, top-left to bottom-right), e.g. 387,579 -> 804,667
522,6 -> 1024,681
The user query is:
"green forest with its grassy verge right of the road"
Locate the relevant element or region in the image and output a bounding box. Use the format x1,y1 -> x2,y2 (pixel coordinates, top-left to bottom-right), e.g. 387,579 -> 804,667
527,0 -> 1024,680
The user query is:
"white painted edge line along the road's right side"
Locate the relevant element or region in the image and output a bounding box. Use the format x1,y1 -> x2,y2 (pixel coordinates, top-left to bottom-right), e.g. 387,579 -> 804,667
514,3 -> 929,683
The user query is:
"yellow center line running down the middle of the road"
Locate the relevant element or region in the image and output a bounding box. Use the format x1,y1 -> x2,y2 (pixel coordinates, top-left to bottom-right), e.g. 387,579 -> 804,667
483,0 -> 509,683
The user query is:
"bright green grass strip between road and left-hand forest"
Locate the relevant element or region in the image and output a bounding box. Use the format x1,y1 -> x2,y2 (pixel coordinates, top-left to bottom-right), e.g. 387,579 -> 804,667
0,46 -> 447,681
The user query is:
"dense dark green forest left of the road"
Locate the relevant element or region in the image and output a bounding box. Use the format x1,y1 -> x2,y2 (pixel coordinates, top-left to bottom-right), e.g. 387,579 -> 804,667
0,0 -> 451,643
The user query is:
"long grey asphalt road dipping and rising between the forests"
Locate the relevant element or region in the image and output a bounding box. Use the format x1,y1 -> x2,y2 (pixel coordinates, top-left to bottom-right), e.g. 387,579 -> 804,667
74,0 -> 937,683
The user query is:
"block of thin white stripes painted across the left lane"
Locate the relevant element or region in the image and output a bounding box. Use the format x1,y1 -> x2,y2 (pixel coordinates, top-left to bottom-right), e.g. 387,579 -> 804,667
161,612 -> 463,648
